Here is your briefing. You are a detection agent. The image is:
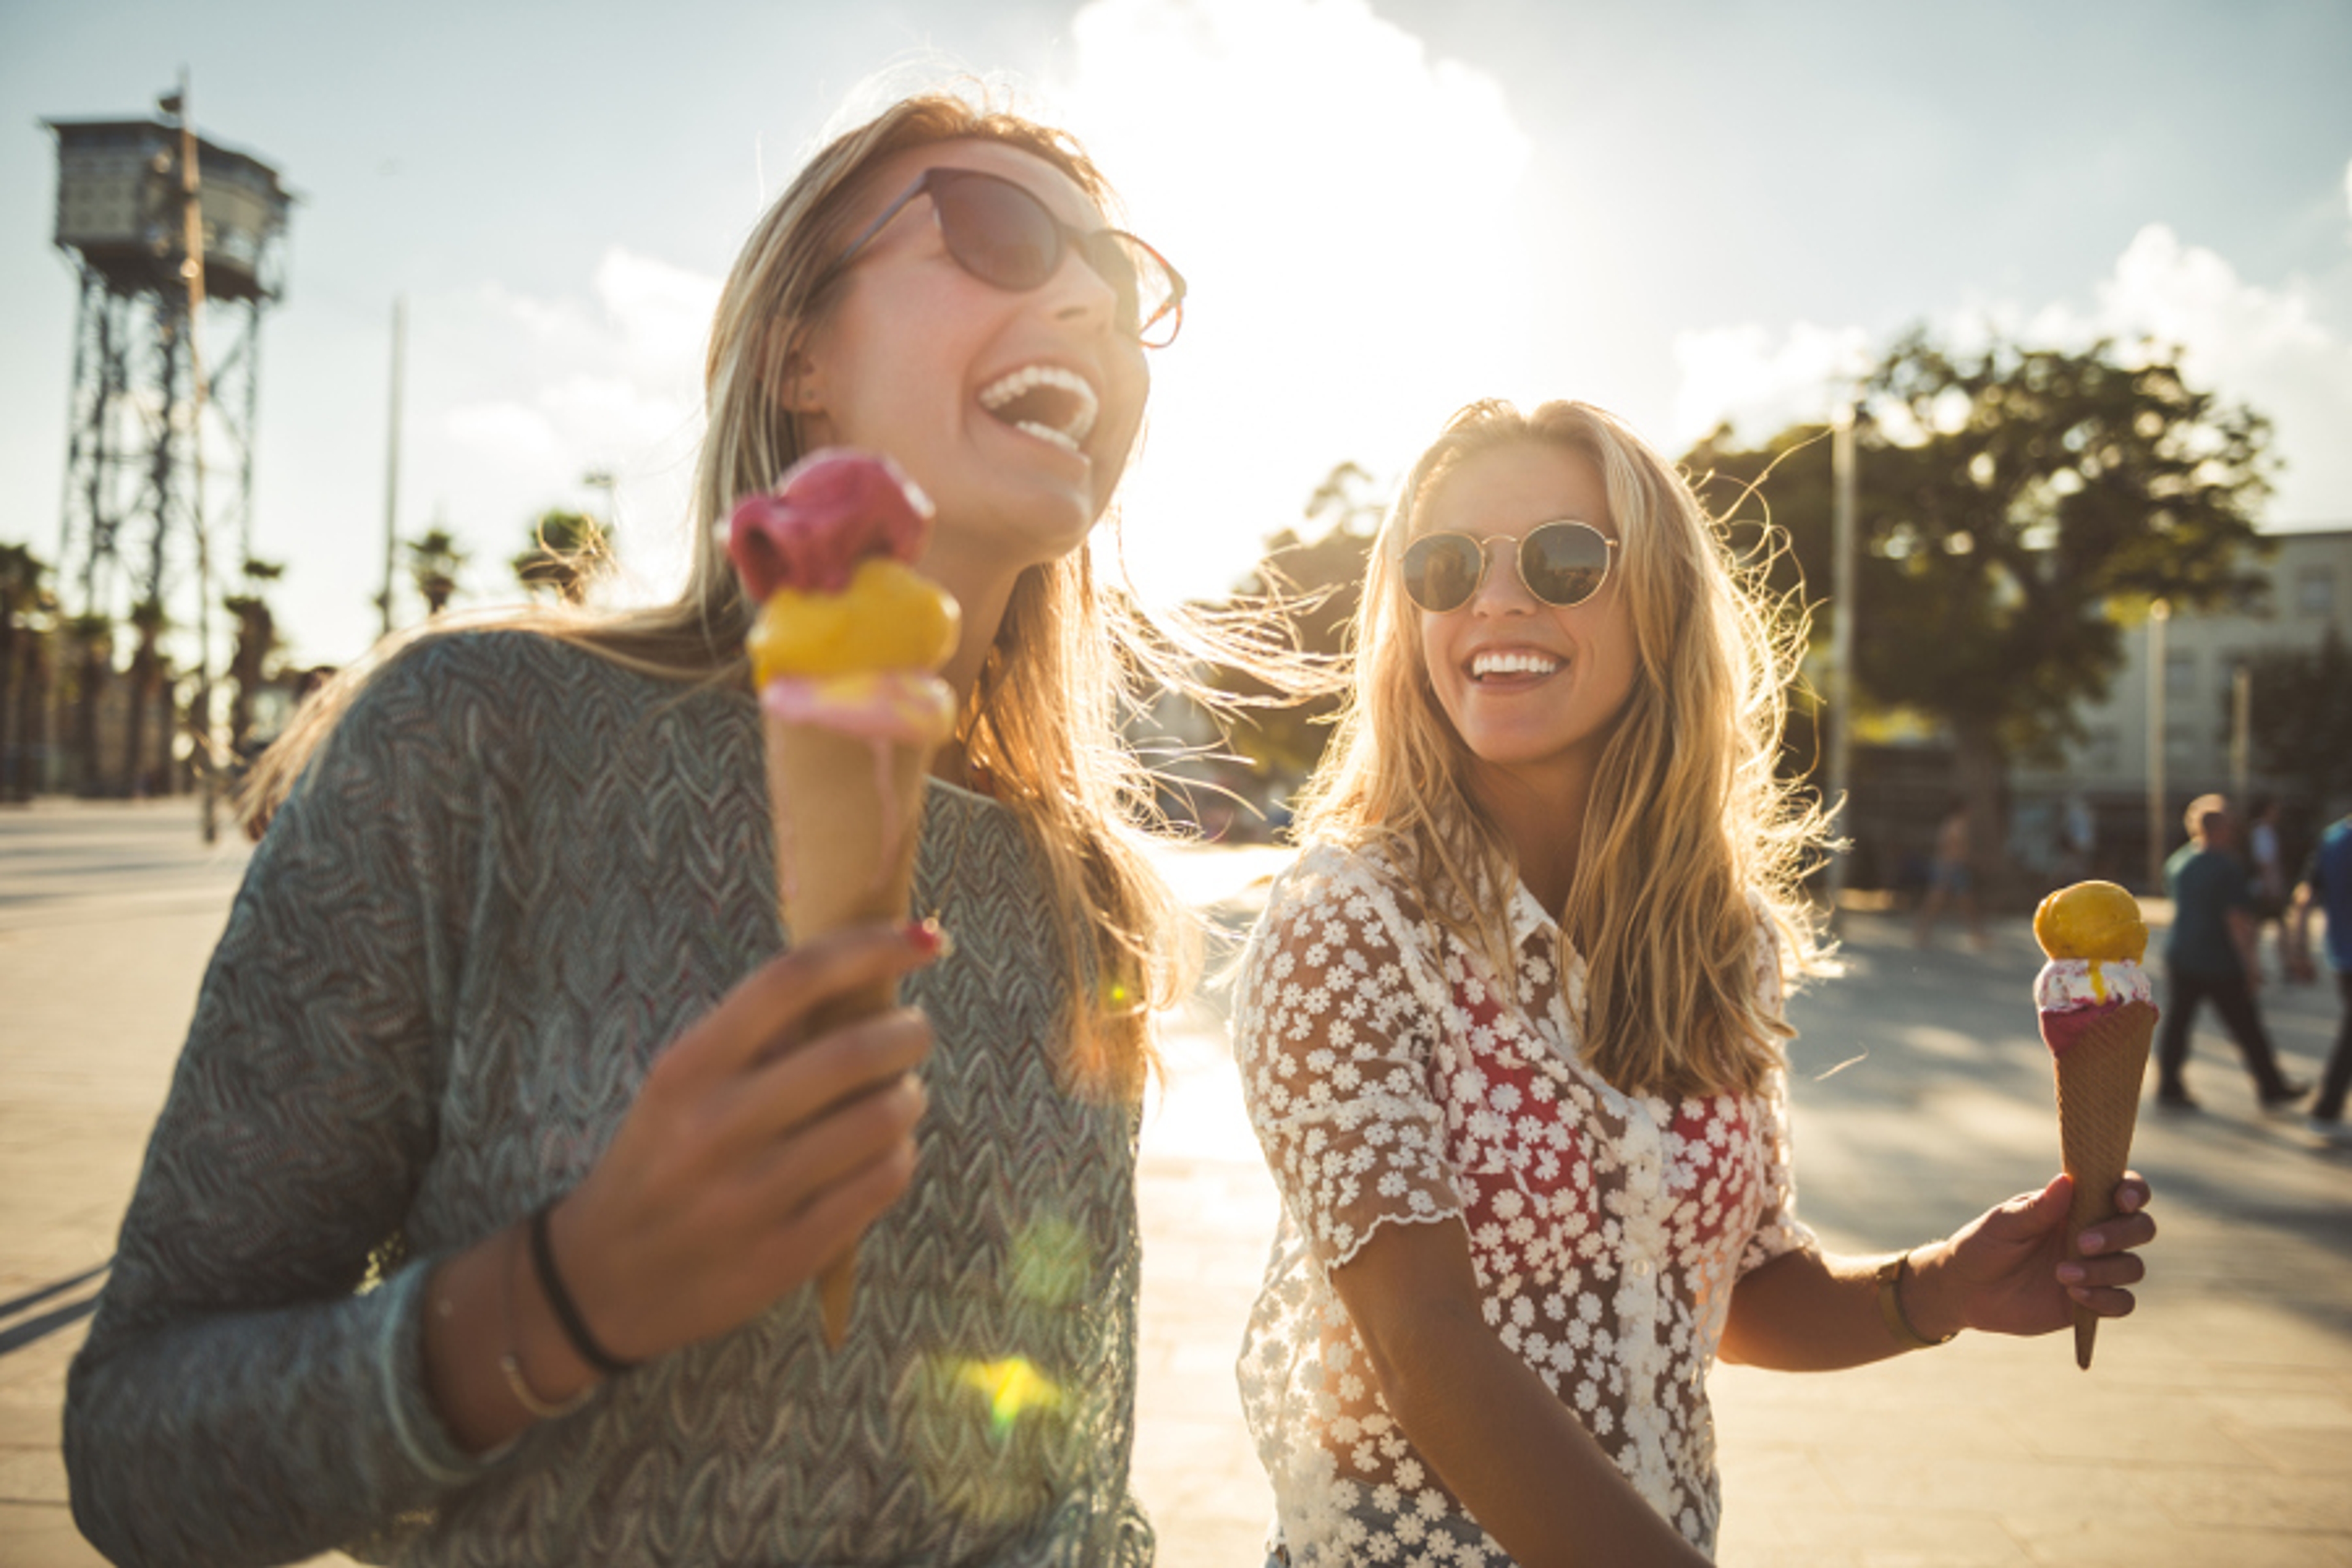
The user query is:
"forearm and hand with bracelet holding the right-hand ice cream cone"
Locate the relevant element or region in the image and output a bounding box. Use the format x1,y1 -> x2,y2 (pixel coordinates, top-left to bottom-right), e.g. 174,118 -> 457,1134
1719,1175 -> 2157,1373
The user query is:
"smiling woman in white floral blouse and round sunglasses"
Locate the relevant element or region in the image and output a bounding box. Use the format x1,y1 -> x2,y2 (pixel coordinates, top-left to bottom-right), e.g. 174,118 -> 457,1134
1235,402 -> 2154,1568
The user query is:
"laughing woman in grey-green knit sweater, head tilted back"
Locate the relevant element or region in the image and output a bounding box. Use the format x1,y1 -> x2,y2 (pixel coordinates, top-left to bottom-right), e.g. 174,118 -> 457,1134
66,96 -> 1183,1563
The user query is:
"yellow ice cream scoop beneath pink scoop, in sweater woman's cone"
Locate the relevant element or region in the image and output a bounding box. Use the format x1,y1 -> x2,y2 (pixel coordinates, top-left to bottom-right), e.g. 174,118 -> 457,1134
745,557 -> 962,687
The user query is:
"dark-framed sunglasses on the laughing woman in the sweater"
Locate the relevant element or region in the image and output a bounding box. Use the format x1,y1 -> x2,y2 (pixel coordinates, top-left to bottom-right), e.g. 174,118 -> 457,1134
828,169 -> 1185,348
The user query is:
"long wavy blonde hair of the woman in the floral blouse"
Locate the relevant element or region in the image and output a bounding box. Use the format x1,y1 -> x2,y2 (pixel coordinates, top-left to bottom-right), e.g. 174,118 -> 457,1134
1298,402 -> 1828,1096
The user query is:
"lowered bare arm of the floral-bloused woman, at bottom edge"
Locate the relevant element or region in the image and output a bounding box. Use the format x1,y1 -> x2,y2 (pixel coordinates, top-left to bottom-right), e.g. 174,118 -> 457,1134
1331,1220 -> 1708,1568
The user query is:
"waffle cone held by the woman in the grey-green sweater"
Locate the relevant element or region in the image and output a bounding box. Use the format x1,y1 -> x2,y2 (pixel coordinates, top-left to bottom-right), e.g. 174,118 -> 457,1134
764,717 -> 938,1349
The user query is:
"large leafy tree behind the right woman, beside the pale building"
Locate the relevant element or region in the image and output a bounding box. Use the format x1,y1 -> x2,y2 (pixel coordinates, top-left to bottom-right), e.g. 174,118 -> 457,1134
1684,331 -> 2272,884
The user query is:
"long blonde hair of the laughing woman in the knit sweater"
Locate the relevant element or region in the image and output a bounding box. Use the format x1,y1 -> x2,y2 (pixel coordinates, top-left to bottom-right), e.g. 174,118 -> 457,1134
243,89 -> 1199,1098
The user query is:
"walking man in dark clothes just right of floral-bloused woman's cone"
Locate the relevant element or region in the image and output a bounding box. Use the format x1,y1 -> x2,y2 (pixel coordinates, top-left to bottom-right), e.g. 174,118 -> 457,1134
2157,794 -> 2312,1110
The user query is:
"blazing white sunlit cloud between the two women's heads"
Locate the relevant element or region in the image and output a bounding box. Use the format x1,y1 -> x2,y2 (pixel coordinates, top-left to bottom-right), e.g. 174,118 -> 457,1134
1049,0 -> 1559,592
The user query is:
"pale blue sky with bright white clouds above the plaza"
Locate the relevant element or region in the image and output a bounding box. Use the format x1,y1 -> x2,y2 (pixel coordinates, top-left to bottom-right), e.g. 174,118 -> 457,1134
0,0 -> 2352,663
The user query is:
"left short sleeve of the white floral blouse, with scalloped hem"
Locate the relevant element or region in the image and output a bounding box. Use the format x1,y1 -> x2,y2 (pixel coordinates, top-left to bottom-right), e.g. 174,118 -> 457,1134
1235,851 -> 1463,1270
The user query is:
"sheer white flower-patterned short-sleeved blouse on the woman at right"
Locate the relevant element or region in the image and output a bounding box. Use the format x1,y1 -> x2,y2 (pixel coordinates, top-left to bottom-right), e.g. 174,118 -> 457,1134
1235,846 -> 1815,1568
